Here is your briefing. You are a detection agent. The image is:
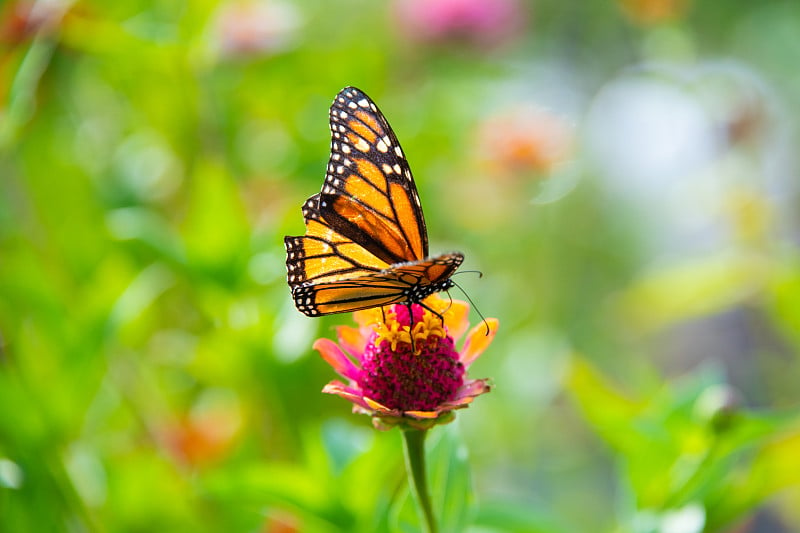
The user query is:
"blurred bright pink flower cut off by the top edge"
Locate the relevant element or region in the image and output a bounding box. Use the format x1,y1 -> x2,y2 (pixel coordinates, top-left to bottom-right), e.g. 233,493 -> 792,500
393,0 -> 526,46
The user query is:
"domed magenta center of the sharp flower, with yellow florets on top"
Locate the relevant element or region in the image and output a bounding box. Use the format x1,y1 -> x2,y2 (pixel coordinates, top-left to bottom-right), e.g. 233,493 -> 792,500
360,304 -> 464,411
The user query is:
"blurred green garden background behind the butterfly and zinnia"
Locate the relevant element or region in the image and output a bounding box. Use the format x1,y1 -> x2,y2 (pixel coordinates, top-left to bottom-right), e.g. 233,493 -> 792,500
0,0 -> 800,533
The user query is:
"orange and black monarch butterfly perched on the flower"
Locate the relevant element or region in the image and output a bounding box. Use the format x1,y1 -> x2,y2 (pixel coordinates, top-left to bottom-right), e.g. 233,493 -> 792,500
284,87 -> 464,316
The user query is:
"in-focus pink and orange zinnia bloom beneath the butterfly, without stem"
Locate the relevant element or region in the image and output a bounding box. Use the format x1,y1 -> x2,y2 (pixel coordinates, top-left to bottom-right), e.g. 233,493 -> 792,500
314,295 -> 499,429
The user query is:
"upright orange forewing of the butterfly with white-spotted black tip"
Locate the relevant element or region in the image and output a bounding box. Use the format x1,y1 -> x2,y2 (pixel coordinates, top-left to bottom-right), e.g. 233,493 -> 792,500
319,87 -> 428,264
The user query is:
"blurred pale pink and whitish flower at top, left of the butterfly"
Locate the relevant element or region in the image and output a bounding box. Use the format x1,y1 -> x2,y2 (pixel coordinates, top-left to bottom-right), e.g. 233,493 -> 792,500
215,0 -> 300,57
